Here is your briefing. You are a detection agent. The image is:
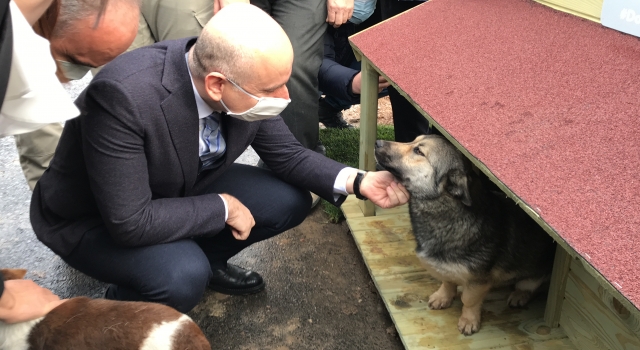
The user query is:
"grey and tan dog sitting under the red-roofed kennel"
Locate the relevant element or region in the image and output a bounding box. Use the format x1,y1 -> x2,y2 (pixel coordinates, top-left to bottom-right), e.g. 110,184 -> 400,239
375,135 -> 555,335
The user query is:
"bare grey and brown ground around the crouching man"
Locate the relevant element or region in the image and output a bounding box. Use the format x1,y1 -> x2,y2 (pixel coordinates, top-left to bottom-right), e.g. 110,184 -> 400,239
0,75 -> 403,350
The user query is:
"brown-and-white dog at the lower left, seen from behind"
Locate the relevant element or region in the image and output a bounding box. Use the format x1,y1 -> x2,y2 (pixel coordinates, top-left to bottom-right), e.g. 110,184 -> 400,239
0,269 -> 211,350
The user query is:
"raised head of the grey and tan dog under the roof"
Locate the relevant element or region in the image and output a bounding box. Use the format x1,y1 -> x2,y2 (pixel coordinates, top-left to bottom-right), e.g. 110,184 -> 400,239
375,135 -> 471,206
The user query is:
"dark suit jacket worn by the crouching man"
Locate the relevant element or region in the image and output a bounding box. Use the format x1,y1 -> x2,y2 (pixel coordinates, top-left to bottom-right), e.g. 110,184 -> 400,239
31,38 -> 345,256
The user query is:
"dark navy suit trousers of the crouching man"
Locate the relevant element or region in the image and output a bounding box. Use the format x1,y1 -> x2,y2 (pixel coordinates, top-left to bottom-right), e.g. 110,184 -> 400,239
63,164 -> 311,312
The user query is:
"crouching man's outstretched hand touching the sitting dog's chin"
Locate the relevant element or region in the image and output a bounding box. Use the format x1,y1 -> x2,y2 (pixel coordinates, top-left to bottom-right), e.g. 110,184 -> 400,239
347,171 -> 409,209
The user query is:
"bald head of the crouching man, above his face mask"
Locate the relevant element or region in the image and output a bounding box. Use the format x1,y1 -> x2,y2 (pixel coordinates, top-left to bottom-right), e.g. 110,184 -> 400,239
189,3 -> 293,85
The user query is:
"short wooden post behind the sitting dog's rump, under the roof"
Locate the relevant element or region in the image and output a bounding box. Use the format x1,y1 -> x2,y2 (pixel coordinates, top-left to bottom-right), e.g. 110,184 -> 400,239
544,244 -> 571,327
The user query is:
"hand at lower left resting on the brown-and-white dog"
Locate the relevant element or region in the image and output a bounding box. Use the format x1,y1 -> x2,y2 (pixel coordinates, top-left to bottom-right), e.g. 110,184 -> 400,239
0,280 -> 66,323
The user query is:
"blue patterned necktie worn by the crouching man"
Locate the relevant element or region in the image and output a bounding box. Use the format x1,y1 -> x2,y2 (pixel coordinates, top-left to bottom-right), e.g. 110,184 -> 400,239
200,112 -> 227,171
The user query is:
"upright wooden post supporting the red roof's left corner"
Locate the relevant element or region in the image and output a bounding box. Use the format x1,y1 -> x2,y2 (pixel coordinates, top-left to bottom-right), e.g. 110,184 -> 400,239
359,57 -> 380,216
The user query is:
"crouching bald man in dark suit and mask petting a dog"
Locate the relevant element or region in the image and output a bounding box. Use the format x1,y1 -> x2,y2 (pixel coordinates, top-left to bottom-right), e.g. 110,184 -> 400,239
31,4 -> 408,312
